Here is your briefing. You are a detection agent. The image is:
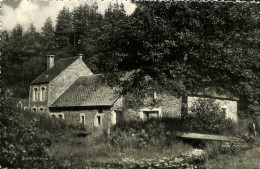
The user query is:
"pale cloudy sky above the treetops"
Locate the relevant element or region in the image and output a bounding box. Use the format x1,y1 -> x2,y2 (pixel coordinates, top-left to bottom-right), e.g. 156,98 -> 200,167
2,0 -> 136,31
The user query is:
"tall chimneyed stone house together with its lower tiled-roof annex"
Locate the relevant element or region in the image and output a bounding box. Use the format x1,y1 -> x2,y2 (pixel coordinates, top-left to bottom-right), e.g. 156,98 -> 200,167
28,55 -> 122,127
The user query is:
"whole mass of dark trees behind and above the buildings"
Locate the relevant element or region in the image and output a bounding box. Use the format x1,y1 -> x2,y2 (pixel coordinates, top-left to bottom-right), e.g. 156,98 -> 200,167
1,2 -> 260,117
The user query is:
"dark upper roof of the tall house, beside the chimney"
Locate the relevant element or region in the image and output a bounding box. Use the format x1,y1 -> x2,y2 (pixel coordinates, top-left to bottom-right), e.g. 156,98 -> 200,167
31,57 -> 79,84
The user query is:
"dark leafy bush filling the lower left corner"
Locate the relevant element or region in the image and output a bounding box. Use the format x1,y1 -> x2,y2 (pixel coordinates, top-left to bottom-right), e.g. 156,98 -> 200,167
0,97 -> 52,168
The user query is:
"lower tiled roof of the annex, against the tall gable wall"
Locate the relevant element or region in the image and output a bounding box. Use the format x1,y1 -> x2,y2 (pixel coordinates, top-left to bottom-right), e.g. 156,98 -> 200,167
50,75 -> 119,107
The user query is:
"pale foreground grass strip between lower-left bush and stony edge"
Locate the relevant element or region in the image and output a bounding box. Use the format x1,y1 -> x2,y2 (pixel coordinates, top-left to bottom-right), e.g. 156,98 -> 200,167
52,130 -> 192,168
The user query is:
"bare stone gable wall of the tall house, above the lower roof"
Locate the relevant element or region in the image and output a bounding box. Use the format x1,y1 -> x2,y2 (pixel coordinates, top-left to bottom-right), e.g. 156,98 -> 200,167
48,59 -> 93,106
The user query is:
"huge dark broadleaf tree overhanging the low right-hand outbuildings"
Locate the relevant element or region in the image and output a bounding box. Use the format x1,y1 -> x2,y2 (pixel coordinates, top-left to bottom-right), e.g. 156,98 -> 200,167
100,2 -> 260,116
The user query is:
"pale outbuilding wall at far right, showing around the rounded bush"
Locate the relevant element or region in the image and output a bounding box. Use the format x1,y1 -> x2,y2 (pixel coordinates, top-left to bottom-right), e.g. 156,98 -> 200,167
187,96 -> 238,121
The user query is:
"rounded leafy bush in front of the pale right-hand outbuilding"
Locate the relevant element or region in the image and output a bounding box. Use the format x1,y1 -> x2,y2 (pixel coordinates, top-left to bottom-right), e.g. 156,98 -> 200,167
184,99 -> 233,134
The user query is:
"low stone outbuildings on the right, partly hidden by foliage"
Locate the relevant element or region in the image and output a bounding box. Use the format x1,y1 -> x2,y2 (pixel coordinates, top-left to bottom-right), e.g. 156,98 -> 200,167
124,90 -> 239,121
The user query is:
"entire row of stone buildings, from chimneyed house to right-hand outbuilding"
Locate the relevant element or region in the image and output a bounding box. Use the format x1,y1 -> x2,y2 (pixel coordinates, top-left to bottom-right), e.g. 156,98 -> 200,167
28,55 -> 238,128
